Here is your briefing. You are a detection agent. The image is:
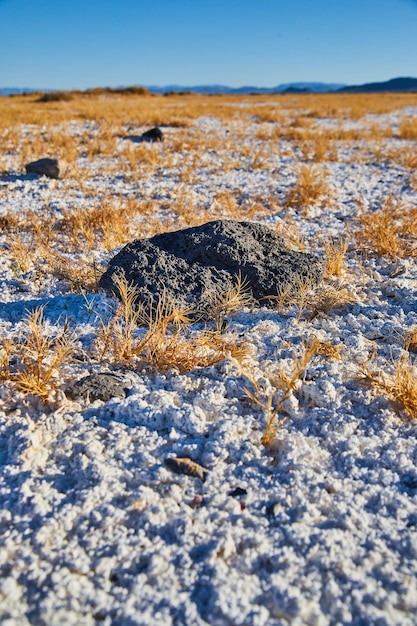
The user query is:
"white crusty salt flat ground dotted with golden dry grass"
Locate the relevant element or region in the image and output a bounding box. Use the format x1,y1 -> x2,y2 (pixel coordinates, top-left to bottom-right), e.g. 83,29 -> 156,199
0,93 -> 417,626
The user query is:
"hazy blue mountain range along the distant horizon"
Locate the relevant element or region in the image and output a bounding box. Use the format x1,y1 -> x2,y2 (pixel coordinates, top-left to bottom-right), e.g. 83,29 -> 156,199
0,77 -> 417,96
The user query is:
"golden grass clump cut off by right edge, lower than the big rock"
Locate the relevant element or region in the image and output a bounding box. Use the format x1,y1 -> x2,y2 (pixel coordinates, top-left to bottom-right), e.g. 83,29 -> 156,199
359,354 -> 417,419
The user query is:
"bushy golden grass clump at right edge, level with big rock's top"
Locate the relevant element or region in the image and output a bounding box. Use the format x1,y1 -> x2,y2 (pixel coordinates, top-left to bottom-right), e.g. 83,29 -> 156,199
354,196 -> 417,258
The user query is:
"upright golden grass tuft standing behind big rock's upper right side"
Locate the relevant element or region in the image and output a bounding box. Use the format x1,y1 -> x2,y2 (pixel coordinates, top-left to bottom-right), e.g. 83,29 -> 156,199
284,165 -> 332,214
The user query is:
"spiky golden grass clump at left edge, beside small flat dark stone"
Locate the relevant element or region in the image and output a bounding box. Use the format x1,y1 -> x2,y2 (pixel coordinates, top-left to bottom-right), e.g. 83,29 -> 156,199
0,307 -> 76,402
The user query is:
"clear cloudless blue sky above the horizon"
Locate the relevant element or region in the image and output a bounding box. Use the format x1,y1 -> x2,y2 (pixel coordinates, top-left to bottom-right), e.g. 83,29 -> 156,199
0,0 -> 417,89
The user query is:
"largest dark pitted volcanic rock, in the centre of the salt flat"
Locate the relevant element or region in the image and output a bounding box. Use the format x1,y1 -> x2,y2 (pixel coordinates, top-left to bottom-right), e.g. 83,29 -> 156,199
100,220 -> 324,311
